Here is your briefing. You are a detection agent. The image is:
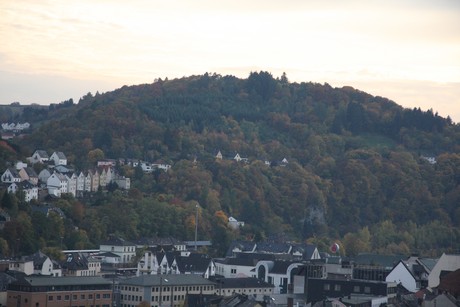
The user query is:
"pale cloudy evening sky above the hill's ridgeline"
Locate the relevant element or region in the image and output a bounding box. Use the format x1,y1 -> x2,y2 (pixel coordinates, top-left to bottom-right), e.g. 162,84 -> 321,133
0,0 -> 460,123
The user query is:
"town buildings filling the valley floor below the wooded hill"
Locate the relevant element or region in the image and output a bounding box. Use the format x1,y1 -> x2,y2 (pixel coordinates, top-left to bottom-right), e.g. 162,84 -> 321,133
0,237 -> 460,307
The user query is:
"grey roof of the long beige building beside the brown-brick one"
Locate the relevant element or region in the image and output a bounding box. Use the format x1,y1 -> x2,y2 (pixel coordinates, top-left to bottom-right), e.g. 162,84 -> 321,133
120,274 -> 215,287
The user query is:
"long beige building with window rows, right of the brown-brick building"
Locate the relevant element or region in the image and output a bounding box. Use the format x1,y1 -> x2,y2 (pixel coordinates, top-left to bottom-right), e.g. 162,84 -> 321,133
120,274 -> 216,307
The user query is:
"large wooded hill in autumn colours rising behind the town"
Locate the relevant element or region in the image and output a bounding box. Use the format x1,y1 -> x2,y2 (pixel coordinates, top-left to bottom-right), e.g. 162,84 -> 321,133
0,72 -> 460,255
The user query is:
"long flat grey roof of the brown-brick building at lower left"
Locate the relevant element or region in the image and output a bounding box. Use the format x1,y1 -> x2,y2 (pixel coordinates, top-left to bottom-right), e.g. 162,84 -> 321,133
13,276 -> 112,286
